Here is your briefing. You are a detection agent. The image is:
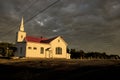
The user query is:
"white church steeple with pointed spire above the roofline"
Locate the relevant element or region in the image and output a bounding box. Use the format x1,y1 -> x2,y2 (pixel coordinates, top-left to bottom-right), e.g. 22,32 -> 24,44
16,17 -> 26,42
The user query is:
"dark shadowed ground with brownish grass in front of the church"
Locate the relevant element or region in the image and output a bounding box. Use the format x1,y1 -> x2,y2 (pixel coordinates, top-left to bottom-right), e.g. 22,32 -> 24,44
0,59 -> 120,80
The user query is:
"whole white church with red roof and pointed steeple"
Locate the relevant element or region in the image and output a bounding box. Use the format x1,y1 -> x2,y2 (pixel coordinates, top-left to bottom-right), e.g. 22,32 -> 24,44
15,18 -> 70,59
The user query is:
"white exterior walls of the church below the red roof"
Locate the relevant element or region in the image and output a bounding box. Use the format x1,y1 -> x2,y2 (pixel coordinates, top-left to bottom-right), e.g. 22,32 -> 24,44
16,37 -> 70,59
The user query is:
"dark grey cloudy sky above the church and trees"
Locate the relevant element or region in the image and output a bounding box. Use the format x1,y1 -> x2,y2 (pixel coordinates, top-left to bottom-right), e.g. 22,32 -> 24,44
0,0 -> 120,55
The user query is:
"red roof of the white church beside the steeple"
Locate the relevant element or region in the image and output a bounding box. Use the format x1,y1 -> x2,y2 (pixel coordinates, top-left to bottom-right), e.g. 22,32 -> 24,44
25,36 -> 57,43
